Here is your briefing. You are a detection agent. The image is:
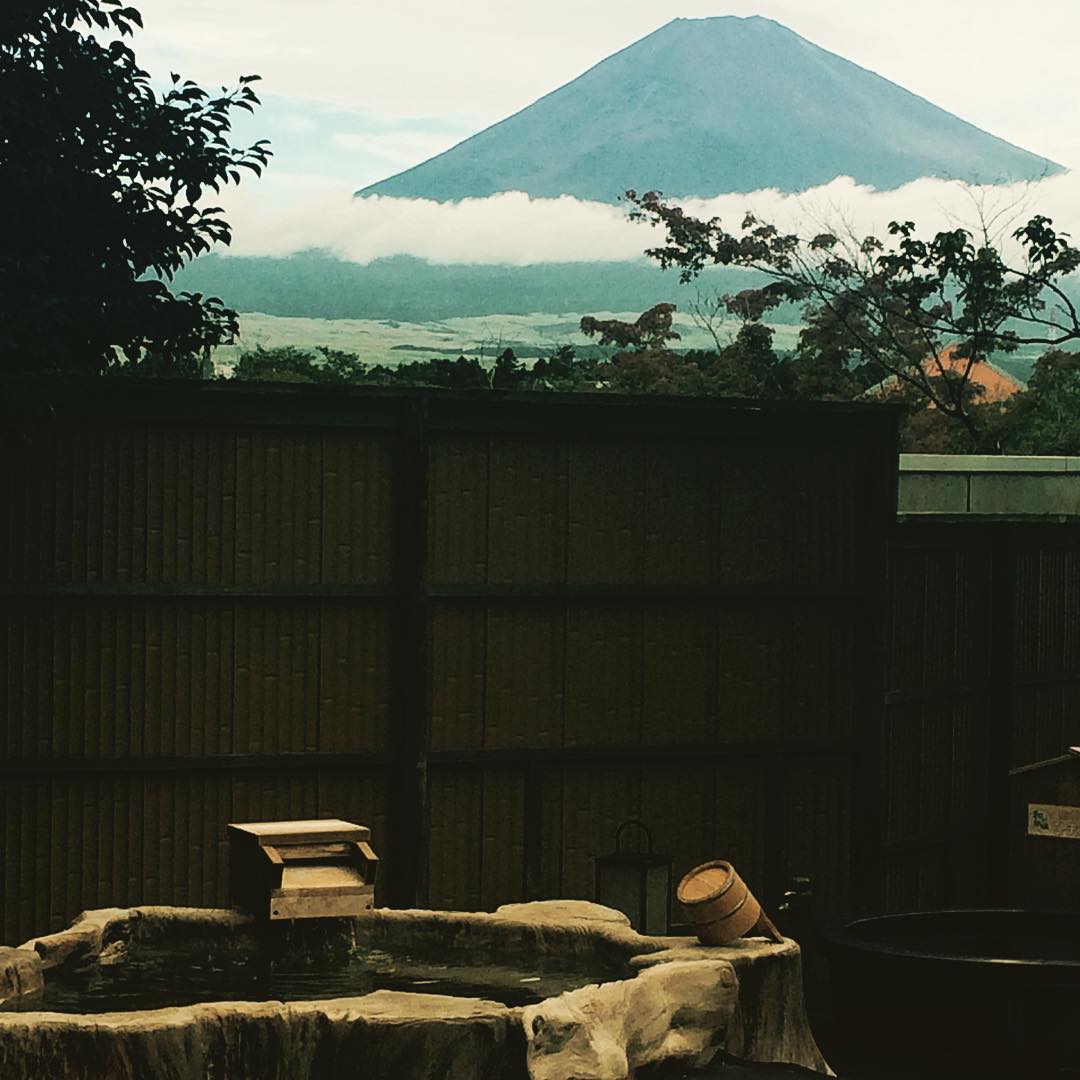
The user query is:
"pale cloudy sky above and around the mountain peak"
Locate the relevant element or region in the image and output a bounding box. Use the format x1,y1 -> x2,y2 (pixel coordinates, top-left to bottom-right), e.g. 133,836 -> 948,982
126,0 -> 1080,258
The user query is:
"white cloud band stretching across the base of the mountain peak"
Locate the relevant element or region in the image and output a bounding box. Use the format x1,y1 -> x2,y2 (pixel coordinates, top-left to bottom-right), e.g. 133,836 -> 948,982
210,172 -> 1080,266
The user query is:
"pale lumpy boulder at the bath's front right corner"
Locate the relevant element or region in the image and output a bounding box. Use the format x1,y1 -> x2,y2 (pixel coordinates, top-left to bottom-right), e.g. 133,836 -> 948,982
522,960 -> 739,1080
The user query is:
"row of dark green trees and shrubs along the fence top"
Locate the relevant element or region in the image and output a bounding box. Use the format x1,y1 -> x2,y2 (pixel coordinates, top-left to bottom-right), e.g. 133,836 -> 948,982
223,332 -> 1080,455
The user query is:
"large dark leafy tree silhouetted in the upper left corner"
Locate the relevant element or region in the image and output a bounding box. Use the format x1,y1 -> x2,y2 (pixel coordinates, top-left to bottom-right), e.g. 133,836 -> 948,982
0,0 -> 270,374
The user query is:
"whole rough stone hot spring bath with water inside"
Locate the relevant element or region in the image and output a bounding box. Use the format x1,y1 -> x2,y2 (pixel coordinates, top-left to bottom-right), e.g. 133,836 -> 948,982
0,901 -> 826,1080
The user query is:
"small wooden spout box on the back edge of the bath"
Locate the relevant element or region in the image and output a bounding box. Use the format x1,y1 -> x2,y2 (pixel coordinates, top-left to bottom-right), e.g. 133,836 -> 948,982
229,819 -> 379,920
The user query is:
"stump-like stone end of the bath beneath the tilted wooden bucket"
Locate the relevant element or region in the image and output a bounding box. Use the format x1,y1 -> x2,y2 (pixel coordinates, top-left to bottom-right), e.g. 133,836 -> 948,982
631,937 -> 833,1076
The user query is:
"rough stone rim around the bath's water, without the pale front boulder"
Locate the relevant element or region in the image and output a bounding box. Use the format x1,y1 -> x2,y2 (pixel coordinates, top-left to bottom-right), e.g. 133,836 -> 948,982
0,901 -> 829,1074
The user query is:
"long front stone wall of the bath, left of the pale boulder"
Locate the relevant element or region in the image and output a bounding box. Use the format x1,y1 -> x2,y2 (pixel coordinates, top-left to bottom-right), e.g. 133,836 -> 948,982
0,990 -> 525,1080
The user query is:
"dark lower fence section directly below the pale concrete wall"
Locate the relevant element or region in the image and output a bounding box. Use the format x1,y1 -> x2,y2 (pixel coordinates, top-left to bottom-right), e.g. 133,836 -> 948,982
883,521 -> 1080,910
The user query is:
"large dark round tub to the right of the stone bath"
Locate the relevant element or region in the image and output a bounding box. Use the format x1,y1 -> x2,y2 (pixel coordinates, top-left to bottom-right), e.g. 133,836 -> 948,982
822,909 -> 1080,1080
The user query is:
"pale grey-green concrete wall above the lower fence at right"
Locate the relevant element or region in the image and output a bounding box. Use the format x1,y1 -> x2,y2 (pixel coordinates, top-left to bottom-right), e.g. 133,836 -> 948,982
897,454 -> 1080,518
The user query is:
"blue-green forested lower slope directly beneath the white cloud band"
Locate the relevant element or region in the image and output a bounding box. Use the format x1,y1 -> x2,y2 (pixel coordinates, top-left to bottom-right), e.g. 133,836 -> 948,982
166,251 -> 799,323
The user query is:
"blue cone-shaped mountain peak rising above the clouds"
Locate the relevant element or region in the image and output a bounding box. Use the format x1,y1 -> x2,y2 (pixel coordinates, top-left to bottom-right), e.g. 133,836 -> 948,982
357,16 -> 1062,202
